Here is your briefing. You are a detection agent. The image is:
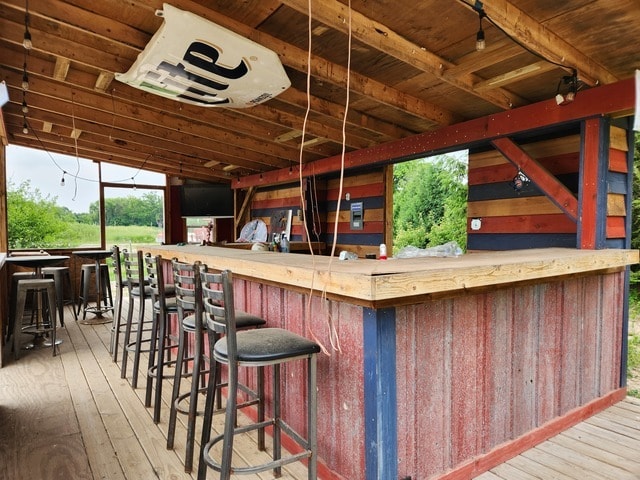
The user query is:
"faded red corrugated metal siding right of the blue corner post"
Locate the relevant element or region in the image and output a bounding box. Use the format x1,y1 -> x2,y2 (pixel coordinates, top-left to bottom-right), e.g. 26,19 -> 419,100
397,273 -> 624,479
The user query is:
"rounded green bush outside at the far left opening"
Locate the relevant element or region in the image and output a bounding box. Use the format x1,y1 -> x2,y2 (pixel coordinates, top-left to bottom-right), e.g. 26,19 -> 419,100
7,180 -> 73,249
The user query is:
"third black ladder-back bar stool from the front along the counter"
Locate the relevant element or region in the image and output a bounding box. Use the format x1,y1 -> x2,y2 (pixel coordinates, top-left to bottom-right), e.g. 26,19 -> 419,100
144,254 -> 178,423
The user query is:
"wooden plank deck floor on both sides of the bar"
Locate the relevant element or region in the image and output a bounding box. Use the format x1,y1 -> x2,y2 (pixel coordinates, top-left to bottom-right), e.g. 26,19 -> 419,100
0,302 -> 640,480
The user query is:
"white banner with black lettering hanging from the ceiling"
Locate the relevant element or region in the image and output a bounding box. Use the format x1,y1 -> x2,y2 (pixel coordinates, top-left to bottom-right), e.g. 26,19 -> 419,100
116,3 -> 291,108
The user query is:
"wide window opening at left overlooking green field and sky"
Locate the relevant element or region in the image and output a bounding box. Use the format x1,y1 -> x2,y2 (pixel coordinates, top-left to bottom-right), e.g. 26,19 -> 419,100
6,145 -> 166,250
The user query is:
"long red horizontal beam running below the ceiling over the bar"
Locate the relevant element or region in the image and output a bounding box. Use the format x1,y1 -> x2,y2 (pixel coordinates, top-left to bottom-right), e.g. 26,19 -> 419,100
232,77 -> 635,188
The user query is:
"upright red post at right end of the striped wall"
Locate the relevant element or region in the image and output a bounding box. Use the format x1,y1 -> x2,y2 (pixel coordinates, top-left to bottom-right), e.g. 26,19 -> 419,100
578,118 -> 609,249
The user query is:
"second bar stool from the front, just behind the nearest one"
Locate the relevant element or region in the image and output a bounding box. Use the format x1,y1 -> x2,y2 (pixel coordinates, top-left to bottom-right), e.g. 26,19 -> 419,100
167,260 -> 267,473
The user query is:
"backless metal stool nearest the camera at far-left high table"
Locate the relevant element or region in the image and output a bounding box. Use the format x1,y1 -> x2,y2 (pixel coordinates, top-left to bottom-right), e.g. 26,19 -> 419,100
12,278 -> 56,360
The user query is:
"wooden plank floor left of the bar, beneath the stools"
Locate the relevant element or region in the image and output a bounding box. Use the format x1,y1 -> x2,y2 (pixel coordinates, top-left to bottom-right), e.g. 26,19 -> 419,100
0,300 -> 307,480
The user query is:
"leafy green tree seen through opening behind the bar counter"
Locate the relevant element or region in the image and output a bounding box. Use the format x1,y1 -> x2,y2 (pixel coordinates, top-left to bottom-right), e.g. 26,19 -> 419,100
393,155 -> 467,251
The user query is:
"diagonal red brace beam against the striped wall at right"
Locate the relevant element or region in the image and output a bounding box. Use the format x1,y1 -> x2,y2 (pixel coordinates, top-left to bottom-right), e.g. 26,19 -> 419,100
491,138 -> 578,222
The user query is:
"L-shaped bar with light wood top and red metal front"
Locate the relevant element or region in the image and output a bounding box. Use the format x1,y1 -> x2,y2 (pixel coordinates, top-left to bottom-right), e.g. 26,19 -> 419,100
143,245 -> 638,480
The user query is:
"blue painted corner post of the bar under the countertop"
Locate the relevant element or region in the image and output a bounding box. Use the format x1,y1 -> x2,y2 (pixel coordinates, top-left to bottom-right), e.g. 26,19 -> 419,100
363,308 -> 398,480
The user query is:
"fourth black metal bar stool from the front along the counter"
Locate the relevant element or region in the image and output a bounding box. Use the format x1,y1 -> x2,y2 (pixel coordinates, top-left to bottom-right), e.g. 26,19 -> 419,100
120,249 -> 153,388
